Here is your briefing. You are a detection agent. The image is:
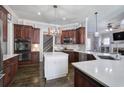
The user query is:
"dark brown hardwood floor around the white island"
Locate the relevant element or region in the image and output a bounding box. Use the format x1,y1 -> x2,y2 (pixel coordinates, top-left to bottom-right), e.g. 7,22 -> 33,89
10,62 -> 74,87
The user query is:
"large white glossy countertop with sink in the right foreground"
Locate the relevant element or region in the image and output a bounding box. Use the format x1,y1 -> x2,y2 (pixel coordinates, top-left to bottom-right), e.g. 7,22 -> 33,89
72,51 -> 124,87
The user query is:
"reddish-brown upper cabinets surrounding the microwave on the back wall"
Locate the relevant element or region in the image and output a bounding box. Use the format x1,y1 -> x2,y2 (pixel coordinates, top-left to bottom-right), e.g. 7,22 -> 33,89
61,27 -> 85,44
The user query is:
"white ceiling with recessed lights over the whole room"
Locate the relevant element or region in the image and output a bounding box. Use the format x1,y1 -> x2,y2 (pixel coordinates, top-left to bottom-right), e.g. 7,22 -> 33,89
10,5 -> 124,31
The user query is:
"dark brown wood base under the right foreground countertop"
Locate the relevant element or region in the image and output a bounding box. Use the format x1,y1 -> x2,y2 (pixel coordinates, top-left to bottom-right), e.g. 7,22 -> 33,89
74,68 -> 103,87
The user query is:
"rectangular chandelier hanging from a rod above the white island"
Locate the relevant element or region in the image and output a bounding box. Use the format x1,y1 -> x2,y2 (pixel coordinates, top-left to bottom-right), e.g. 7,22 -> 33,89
48,5 -> 62,35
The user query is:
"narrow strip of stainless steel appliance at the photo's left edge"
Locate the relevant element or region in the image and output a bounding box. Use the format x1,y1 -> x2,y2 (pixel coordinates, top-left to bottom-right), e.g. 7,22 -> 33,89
0,20 -> 4,87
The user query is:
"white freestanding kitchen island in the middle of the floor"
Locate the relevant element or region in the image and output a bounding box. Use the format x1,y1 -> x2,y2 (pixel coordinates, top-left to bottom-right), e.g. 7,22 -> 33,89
44,52 -> 68,80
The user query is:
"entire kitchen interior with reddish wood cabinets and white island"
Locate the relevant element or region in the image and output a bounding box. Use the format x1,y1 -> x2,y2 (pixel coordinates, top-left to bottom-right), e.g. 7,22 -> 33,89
0,5 -> 124,87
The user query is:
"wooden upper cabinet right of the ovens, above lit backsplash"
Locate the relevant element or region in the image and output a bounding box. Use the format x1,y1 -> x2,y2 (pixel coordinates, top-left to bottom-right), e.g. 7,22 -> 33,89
31,28 -> 40,44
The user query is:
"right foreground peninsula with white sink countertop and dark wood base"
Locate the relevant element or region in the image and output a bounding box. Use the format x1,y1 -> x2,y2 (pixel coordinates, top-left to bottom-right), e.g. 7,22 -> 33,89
72,51 -> 124,87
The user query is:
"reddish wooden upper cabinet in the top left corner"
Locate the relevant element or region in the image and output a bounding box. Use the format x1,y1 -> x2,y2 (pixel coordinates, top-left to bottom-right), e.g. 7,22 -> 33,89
0,5 -> 8,42
